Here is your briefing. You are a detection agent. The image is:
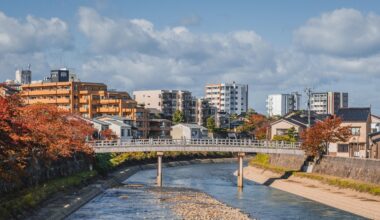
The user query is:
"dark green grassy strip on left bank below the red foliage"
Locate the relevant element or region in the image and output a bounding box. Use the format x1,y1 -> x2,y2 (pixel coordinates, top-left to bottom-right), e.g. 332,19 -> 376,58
0,171 -> 97,219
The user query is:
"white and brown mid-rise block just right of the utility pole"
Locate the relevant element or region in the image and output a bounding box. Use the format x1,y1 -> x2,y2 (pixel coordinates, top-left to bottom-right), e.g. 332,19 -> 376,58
310,92 -> 348,115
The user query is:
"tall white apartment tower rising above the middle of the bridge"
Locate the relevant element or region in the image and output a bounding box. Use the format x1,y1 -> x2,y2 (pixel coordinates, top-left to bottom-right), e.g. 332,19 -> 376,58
205,82 -> 248,115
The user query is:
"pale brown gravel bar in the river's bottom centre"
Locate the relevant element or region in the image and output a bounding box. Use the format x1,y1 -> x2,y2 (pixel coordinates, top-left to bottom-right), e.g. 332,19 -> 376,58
150,188 -> 250,220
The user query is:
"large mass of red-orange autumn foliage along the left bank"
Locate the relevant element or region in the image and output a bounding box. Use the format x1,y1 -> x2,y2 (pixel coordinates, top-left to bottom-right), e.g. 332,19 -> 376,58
0,96 -> 93,180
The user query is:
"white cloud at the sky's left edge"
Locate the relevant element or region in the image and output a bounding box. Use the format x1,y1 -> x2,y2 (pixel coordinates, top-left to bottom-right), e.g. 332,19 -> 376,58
0,12 -> 72,53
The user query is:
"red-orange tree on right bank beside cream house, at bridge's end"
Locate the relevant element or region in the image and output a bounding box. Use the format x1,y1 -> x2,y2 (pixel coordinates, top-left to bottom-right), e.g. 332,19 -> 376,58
301,117 -> 351,156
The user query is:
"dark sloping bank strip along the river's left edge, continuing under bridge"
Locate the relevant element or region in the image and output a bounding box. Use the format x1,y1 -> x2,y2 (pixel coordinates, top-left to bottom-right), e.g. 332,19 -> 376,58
28,158 -> 248,220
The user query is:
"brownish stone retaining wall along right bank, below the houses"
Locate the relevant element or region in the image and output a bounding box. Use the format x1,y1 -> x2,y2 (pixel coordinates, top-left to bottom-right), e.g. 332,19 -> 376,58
269,154 -> 380,184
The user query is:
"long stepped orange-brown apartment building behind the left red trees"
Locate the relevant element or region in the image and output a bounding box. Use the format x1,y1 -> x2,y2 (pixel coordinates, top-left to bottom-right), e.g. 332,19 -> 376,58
21,81 -> 148,137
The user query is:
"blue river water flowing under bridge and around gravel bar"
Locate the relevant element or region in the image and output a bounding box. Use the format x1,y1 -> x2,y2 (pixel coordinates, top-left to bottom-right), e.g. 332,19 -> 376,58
69,163 -> 362,220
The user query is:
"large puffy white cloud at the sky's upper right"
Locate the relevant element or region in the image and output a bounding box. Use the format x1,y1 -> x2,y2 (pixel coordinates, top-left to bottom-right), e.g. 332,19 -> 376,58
294,8 -> 380,57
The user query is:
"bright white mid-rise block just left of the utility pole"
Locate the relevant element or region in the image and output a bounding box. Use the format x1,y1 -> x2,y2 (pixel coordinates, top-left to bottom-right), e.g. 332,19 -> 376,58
266,92 -> 301,117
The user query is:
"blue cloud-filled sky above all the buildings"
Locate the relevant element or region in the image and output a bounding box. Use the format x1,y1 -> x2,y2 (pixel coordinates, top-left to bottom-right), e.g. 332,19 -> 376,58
0,0 -> 380,114
